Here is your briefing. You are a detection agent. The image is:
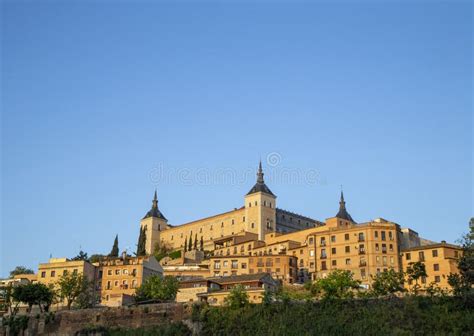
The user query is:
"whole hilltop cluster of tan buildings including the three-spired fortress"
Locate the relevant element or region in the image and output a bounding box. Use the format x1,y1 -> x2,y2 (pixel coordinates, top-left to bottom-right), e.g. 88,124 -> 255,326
20,164 -> 462,306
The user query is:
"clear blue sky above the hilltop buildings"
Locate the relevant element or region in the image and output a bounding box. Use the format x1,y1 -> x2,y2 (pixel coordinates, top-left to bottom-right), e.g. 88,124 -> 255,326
0,0 -> 473,276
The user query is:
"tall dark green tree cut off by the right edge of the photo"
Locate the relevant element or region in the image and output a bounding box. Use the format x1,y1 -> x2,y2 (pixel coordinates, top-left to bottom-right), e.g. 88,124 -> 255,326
448,232 -> 474,296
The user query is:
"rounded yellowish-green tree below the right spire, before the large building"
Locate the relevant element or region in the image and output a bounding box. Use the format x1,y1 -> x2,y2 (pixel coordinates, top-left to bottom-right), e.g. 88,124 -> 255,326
310,270 -> 360,299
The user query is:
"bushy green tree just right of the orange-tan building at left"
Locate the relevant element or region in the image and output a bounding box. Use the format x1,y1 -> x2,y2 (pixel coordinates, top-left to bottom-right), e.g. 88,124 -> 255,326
136,275 -> 179,302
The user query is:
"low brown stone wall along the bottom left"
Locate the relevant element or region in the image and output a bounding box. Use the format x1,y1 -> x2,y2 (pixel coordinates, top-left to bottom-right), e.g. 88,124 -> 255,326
0,303 -> 190,336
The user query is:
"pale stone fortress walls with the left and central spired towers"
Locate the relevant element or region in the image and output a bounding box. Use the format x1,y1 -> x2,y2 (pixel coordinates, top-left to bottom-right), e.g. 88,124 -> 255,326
140,163 -> 323,254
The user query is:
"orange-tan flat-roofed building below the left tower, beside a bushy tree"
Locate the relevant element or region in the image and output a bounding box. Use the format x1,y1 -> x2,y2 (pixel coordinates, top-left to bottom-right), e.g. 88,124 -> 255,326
96,255 -> 163,306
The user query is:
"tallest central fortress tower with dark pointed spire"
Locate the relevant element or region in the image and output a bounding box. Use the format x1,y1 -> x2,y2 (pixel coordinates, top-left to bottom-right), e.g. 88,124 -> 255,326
245,161 -> 276,240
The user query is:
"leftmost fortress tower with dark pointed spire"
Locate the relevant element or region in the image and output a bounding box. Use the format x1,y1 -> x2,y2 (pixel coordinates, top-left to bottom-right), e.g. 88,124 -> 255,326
140,189 -> 169,254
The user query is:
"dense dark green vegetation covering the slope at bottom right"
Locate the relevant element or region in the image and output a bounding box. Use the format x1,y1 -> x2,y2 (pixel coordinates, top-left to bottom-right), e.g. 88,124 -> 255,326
193,296 -> 474,336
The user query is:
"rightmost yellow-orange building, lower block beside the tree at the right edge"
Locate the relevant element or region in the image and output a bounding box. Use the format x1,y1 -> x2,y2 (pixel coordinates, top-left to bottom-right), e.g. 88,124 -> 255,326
402,241 -> 462,290
